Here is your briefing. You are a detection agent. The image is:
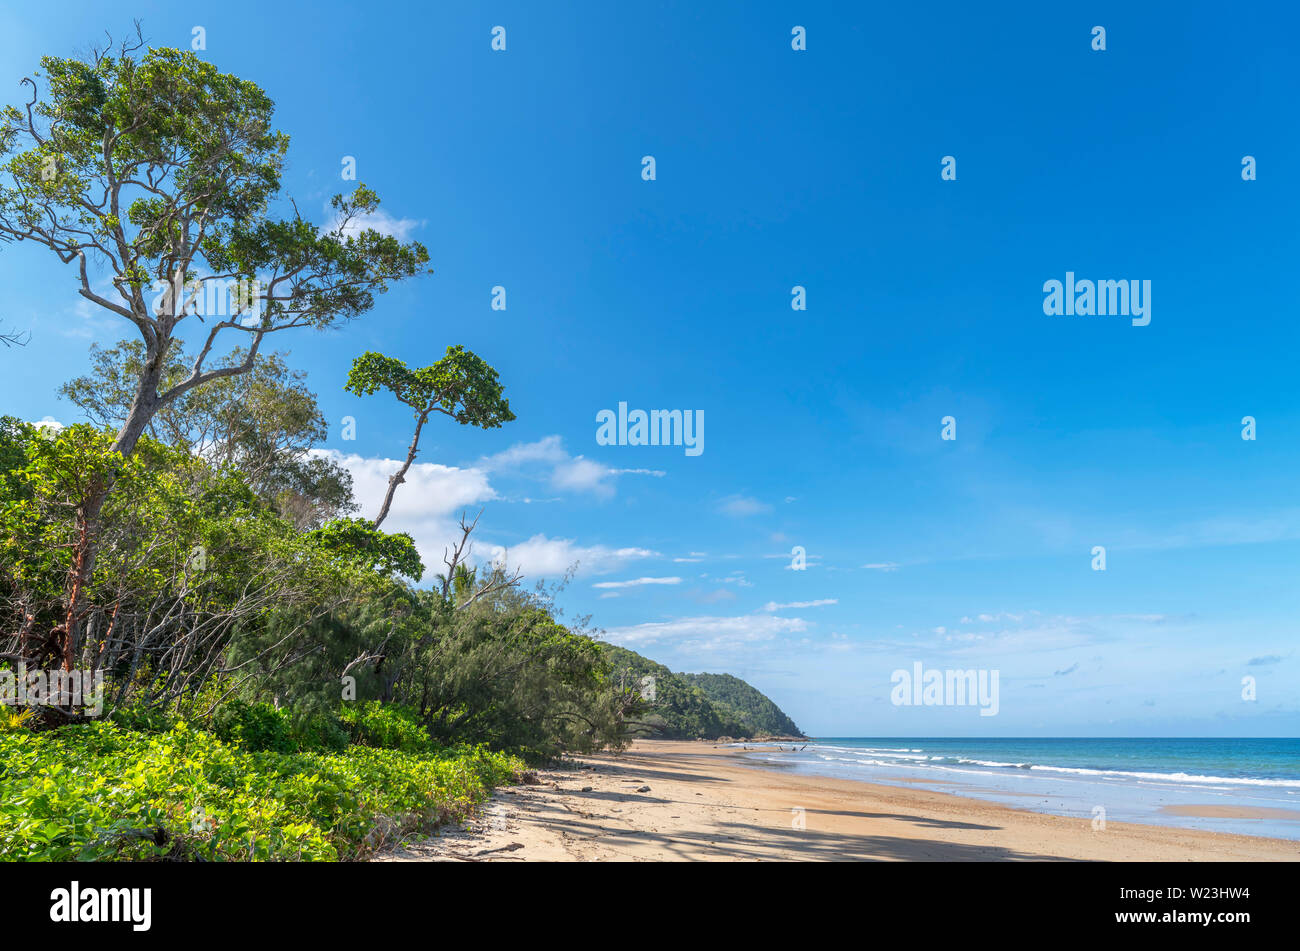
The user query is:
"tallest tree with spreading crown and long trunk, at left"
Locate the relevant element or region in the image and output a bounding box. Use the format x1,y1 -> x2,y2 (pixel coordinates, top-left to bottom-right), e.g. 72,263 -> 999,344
0,29 -> 428,639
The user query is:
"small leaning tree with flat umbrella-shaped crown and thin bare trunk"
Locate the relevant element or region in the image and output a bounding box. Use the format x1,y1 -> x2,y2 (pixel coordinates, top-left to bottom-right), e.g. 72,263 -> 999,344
345,346 -> 515,527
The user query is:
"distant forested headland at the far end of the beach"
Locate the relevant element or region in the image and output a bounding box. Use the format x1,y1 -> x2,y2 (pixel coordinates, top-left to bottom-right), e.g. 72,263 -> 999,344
602,644 -> 803,739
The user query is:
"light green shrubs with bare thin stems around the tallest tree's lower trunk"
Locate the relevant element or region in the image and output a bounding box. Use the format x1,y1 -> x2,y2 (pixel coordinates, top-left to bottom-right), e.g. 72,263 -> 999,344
0,424 -> 366,707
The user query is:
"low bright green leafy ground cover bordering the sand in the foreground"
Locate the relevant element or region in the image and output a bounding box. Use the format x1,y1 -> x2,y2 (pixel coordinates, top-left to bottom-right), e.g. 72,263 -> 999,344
0,722 -> 523,861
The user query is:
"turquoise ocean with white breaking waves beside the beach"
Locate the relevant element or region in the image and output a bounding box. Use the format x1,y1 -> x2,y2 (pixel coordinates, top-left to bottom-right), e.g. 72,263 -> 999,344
736,737 -> 1300,847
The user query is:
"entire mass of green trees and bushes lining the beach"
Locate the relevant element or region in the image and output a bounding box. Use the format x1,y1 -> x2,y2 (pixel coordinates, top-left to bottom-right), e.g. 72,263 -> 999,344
0,35 -> 793,859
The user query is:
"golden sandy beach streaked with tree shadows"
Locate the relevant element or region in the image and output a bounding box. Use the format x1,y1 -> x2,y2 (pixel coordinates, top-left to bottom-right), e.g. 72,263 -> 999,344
378,741 -> 1300,861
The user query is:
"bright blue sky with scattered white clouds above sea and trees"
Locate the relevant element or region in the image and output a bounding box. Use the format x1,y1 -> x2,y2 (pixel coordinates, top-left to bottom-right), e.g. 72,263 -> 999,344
0,0 -> 1300,735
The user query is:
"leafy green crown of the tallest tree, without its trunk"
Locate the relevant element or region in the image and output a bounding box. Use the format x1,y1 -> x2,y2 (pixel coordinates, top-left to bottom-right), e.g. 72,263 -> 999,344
0,44 -> 428,329
